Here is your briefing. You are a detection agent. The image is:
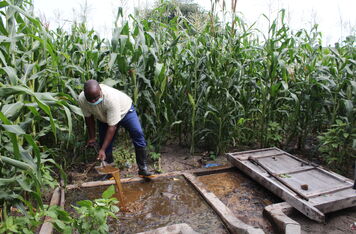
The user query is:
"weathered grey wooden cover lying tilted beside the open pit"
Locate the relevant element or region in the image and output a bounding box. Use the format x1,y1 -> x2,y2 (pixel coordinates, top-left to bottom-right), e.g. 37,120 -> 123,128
227,148 -> 356,222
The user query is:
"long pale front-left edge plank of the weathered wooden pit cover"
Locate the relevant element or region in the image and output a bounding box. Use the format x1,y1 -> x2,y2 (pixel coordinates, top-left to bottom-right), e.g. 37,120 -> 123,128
227,154 -> 325,222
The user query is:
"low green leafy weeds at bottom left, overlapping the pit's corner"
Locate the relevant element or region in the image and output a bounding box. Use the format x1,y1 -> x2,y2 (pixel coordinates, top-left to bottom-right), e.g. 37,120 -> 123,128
0,185 -> 119,234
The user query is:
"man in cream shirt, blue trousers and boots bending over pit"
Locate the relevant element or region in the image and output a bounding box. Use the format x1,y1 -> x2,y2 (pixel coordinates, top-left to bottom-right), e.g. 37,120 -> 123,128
79,80 -> 152,177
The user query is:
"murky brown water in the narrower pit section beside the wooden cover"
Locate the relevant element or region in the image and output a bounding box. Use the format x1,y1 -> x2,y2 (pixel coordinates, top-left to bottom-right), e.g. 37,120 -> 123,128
198,169 -> 282,233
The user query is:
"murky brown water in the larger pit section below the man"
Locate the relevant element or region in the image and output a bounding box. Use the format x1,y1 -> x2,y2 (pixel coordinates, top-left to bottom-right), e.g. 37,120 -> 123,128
66,177 -> 228,233
